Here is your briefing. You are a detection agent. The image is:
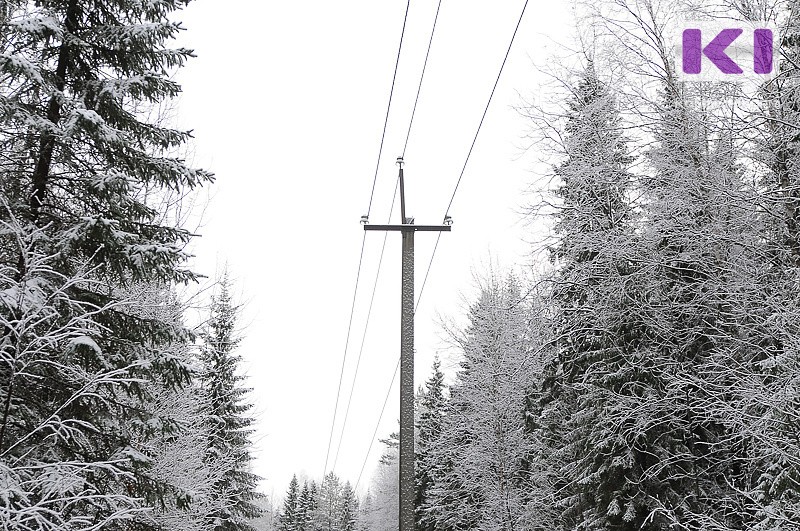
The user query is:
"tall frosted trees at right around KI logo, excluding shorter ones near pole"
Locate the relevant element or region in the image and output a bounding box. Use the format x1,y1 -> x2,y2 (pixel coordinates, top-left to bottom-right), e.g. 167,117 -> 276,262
512,0 -> 800,531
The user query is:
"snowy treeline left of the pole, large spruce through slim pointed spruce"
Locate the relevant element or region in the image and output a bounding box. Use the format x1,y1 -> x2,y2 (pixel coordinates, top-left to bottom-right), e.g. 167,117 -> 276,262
0,0 -> 259,531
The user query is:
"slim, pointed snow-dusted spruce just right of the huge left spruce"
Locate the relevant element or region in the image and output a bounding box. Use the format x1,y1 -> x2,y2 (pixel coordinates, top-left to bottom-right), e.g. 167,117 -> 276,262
201,273 -> 260,531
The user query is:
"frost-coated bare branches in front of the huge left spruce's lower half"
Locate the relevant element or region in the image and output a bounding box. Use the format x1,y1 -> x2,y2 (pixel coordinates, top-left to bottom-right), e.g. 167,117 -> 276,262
0,211 -> 166,530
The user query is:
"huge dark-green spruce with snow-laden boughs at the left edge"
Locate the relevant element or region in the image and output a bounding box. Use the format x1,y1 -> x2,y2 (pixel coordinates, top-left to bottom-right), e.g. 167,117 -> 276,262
0,0 -> 211,530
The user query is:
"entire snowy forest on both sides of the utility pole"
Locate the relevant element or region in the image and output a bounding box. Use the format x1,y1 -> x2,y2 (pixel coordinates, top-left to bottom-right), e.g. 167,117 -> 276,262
0,0 -> 800,531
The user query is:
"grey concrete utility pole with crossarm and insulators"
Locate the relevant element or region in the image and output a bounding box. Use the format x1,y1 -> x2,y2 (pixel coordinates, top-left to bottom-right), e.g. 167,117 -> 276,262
362,157 -> 450,531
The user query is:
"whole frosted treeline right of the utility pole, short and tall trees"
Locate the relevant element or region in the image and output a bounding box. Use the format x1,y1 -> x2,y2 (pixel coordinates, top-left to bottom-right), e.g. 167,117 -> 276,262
417,0 -> 800,531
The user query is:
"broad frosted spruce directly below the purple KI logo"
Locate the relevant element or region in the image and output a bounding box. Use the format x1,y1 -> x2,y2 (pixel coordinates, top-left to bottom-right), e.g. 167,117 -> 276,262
621,77 -> 763,529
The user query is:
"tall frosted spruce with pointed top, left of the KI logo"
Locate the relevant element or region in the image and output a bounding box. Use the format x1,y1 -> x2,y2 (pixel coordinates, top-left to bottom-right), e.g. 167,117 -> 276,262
528,61 -> 639,529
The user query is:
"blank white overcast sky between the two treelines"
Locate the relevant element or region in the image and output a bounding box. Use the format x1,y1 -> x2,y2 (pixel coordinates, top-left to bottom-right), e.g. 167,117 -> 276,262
173,0 -> 572,499
